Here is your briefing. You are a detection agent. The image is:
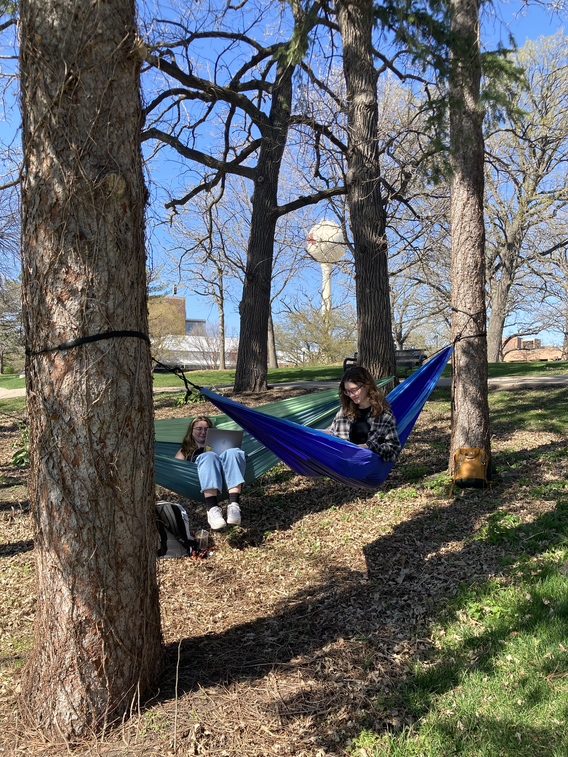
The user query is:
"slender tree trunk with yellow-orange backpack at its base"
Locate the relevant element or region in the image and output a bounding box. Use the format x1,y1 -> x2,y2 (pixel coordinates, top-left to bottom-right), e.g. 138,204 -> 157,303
450,0 -> 490,469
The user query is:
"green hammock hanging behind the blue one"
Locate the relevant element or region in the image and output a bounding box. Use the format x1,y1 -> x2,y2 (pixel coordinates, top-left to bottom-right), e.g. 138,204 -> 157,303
154,376 -> 392,501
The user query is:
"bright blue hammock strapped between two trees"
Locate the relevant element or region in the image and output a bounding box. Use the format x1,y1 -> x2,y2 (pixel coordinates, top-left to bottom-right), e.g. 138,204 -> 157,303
201,347 -> 453,489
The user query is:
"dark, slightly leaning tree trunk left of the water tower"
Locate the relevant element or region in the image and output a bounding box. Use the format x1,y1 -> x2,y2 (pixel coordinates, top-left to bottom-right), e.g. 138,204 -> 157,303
235,62 -> 294,392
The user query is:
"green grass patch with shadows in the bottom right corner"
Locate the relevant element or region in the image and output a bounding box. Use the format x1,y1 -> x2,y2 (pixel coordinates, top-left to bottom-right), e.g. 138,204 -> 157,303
350,499 -> 568,757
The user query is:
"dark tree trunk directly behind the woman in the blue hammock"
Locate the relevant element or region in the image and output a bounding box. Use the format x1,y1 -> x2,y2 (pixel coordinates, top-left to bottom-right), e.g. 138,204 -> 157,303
336,0 -> 396,376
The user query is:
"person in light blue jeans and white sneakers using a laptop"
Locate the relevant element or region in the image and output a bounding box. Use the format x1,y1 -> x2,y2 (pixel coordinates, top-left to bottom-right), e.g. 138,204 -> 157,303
176,415 -> 246,531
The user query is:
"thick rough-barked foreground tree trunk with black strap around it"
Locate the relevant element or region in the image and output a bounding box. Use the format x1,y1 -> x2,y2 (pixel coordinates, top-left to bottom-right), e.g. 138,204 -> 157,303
20,0 -> 161,741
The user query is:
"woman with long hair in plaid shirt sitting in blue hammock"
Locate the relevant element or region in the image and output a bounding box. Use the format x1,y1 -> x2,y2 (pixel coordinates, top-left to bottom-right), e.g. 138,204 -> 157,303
327,366 -> 401,463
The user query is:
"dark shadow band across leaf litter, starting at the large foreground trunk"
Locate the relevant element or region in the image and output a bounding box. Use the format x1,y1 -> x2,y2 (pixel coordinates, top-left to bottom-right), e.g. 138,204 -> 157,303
149,488 -> 508,730
